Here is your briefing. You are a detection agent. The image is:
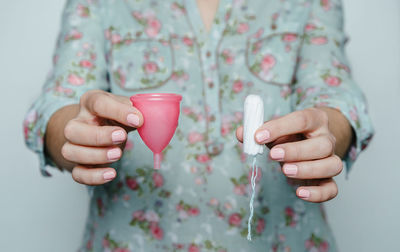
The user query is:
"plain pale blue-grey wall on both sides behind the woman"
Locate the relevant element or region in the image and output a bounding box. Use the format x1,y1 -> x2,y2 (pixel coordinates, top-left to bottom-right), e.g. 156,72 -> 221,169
0,0 -> 400,252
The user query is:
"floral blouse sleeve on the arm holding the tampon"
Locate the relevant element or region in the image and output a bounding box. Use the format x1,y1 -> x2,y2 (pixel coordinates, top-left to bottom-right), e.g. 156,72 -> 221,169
291,0 -> 373,173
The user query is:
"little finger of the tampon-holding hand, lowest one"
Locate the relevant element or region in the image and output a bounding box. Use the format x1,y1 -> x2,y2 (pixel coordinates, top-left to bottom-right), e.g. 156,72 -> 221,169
296,179 -> 338,203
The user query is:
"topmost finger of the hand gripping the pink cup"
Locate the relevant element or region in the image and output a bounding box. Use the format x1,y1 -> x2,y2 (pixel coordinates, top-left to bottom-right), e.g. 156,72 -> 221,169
81,91 -> 143,128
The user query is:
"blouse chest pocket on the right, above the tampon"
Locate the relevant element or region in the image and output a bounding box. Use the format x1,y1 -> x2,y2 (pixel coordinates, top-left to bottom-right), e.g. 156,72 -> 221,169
245,24 -> 303,86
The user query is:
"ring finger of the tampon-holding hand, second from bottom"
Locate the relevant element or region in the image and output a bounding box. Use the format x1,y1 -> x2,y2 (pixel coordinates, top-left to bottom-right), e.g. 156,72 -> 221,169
282,155 -> 343,179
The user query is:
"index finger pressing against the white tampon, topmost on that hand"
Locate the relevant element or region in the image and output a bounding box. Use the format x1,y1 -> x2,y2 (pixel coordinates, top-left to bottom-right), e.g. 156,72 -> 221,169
255,108 -> 328,144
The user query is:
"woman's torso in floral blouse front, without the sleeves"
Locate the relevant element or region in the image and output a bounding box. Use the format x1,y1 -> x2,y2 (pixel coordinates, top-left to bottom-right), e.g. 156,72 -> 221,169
82,0 -> 335,251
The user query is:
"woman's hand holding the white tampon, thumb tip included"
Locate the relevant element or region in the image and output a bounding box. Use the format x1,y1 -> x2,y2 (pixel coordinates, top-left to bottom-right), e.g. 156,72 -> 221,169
236,108 -> 352,202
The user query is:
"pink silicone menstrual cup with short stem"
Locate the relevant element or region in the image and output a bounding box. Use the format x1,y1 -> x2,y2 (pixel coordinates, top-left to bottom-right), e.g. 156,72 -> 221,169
131,93 -> 182,169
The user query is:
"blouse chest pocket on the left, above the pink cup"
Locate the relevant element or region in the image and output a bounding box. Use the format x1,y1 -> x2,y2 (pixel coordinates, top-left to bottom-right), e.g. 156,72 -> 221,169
109,30 -> 175,92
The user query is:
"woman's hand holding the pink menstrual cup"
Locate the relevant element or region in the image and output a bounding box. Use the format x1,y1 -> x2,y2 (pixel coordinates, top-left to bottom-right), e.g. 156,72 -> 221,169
46,90 -> 143,185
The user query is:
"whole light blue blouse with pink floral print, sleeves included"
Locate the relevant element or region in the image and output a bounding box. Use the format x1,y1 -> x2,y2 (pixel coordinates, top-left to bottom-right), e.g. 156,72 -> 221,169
24,0 -> 373,252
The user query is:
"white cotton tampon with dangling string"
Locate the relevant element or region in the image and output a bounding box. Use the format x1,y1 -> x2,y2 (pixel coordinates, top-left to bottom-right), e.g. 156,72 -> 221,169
243,95 -> 264,241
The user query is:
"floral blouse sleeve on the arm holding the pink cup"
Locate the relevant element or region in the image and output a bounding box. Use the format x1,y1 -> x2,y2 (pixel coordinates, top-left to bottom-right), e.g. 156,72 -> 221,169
24,0 -> 109,176
